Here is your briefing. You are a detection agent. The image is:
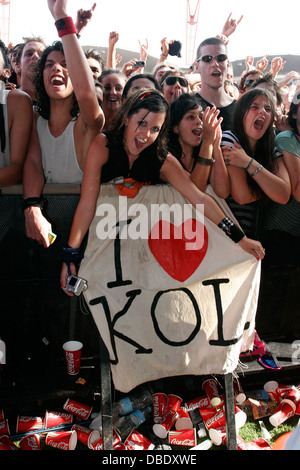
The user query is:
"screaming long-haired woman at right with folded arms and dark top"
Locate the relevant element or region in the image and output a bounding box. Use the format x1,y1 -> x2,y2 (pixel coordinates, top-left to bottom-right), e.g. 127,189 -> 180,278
221,87 -> 291,237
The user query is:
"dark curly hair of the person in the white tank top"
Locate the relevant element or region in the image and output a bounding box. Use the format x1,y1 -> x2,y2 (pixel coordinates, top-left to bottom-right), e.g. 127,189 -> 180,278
34,41 -> 79,119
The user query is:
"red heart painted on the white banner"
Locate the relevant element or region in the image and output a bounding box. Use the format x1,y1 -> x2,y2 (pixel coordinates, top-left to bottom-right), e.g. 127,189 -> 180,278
148,219 -> 208,282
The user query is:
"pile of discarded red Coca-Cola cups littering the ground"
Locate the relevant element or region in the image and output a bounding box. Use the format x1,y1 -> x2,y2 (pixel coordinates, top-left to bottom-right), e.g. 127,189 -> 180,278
0,378 -> 300,450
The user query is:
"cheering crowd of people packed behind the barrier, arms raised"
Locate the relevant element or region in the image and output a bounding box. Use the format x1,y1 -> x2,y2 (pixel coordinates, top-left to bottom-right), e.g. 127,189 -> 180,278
0,0 -> 300,286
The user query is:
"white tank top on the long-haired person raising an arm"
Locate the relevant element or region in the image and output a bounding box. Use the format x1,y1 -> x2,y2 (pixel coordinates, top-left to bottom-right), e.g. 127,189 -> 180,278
37,116 -> 83,184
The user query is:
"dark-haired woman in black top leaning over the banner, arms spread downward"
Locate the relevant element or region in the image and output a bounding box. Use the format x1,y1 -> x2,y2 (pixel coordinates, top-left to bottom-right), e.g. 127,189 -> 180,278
61,88 -> 264,287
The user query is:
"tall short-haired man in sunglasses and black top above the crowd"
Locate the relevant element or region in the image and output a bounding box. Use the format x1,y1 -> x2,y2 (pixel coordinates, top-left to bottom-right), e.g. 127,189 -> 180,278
196,37 -> 236,131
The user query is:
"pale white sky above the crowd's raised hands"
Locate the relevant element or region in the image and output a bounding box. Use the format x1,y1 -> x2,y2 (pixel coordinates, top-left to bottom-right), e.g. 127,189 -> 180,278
4,0 -> 300,66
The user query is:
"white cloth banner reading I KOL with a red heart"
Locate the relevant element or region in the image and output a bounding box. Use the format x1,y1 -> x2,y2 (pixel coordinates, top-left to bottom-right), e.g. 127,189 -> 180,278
79,184 -> 260,393
